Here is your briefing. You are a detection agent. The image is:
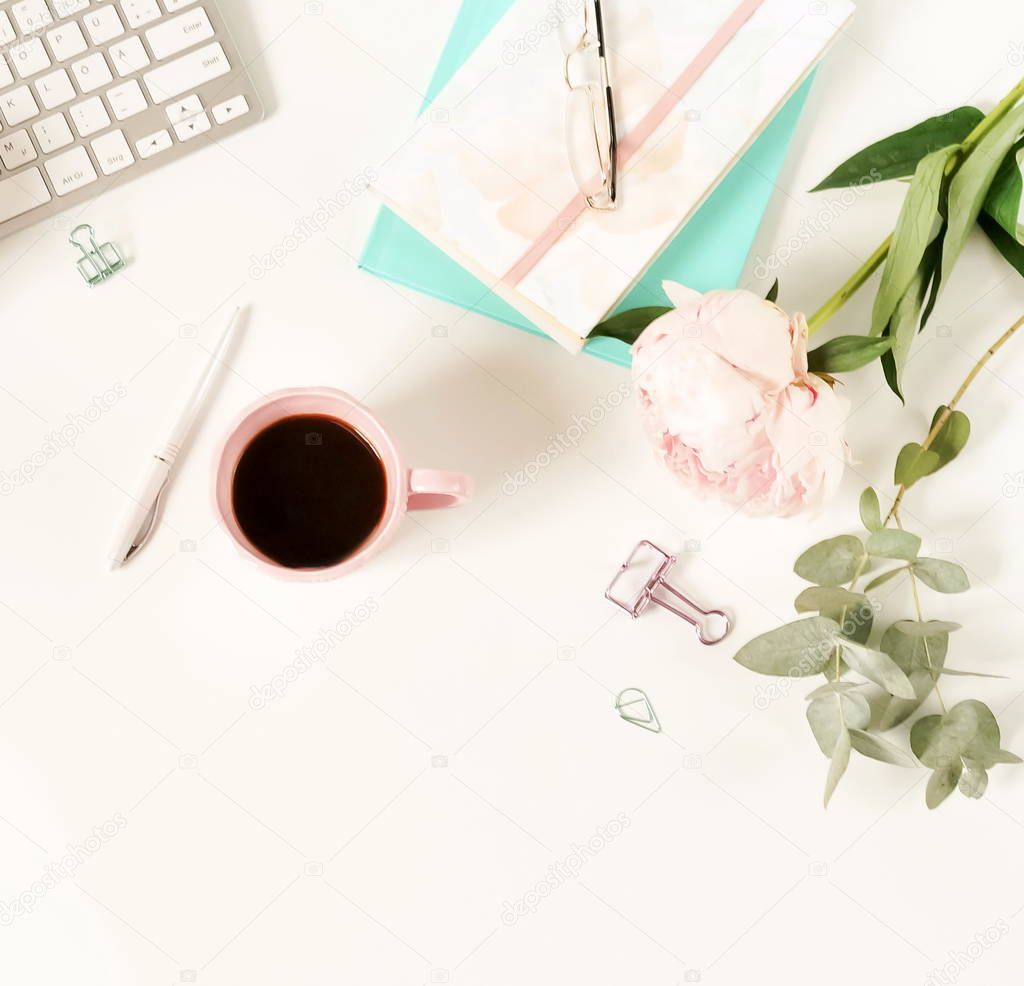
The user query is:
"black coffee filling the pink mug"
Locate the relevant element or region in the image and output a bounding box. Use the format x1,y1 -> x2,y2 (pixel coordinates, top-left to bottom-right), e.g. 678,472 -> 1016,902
231,415 -> 387,568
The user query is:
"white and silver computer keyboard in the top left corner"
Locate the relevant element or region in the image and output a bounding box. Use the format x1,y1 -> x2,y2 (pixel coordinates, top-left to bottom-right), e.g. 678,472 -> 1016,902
0,0 -> 263,237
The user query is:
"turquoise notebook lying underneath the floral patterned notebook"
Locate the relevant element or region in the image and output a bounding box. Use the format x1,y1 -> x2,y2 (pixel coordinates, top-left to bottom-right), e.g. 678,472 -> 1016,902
359,0 -> 813,367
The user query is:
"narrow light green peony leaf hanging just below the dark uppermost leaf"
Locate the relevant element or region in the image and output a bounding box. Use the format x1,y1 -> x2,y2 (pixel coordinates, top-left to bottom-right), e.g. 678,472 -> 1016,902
870,144 -> 957,339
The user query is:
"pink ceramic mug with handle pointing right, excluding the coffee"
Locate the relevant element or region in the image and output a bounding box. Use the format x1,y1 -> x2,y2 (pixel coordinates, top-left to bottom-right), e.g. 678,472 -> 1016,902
214,387 -> 473,582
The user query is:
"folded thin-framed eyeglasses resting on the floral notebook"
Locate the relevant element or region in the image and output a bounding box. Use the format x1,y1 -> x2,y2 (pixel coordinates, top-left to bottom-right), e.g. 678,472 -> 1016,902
565,0 -> 618,210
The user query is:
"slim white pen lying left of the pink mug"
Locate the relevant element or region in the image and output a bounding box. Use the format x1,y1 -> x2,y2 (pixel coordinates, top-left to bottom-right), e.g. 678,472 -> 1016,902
110,308 -> 242,571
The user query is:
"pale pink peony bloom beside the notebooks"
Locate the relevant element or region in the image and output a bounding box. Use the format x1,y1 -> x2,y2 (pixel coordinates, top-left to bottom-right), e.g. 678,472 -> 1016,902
633,282 -> 849,517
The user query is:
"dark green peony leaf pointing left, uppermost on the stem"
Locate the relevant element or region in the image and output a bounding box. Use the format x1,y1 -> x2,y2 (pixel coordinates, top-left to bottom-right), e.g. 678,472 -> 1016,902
811,106 -> 984,191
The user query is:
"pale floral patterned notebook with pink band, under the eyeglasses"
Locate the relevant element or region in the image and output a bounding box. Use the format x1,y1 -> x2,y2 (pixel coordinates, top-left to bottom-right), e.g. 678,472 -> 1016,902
377,0 -> 853,350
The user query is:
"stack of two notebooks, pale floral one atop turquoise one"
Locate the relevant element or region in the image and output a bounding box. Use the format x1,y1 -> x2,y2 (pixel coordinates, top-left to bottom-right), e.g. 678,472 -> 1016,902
360,0 -> 853,365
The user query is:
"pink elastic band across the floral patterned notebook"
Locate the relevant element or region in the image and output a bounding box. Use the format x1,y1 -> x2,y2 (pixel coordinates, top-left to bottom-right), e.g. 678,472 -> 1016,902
502,0 -> 764,288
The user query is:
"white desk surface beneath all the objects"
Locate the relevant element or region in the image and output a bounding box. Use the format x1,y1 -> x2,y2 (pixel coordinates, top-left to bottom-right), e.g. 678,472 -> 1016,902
0,0 -> 1024,986
